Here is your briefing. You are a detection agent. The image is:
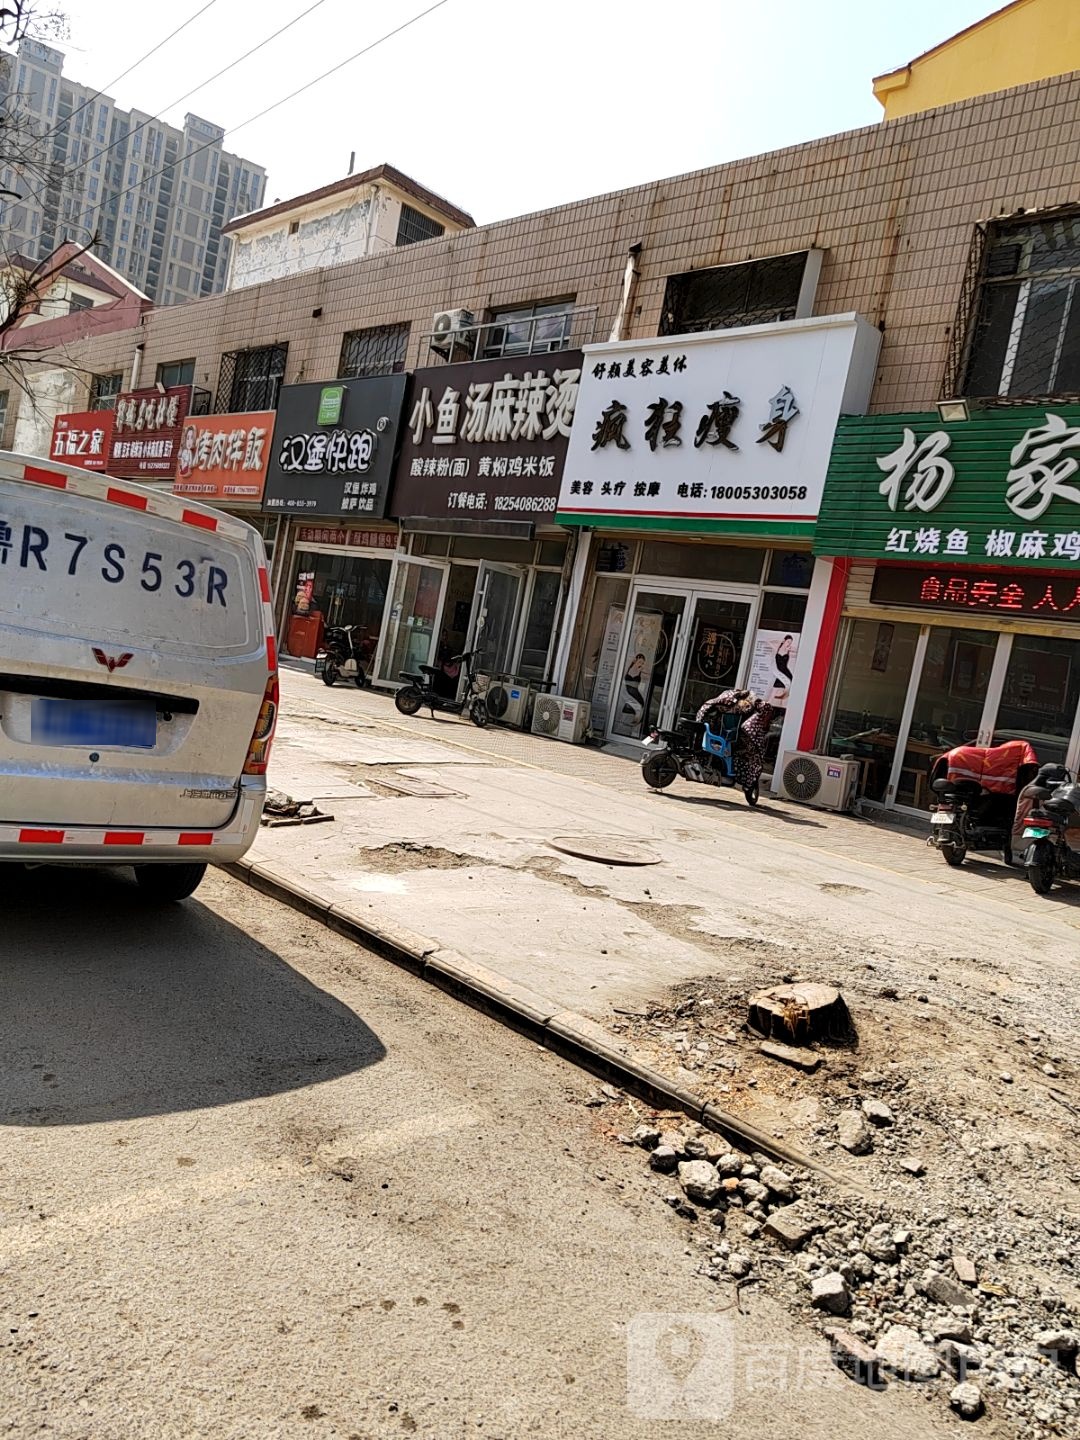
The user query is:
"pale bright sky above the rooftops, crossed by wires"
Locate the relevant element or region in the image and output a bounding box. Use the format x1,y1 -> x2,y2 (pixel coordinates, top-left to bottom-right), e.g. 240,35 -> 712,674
60,0 -> 996,222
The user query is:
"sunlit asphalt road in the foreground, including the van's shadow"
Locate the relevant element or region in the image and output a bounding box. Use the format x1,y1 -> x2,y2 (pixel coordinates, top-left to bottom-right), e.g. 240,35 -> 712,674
0,871 -> 952,1440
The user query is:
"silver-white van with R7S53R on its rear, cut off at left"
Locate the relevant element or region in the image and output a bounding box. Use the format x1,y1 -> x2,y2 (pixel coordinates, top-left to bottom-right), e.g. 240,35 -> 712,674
0,451 -> 278,900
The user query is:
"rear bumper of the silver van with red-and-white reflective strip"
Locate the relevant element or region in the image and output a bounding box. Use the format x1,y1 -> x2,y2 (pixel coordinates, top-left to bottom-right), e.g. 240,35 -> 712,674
0,776 -> 266,865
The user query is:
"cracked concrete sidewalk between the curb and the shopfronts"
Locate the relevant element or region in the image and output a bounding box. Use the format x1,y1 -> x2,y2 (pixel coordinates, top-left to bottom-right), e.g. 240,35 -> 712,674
252,671 -> 1080,1020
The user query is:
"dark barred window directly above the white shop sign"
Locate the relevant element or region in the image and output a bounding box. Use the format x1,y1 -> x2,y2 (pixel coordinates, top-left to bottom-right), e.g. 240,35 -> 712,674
660,251 -> 808,336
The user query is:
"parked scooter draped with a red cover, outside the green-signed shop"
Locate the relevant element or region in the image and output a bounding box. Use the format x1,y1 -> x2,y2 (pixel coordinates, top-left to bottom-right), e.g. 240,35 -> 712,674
926,740 -> 1038,865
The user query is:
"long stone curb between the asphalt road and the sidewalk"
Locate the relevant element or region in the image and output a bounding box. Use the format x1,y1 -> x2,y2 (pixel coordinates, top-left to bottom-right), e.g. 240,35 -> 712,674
220,860 -> 858,1188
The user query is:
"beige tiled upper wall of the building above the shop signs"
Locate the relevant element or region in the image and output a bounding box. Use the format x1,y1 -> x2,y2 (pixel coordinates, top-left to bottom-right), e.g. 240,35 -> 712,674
46,75 -> 1080,410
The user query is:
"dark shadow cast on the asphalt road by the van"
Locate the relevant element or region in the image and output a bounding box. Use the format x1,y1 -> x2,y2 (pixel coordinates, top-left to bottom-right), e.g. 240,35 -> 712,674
0,867 -> 386,1126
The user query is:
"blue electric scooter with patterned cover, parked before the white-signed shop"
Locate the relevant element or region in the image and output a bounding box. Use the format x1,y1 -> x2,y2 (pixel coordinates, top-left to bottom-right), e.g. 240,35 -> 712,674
641,690 -> 773,805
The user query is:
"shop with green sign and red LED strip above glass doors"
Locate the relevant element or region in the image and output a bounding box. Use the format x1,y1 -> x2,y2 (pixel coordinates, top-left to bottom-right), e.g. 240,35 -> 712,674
806,405 -> 1080,811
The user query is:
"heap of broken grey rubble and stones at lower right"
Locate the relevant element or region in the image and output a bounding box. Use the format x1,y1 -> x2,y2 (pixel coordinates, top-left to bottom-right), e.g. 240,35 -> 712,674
621,1111 -> 1080,1437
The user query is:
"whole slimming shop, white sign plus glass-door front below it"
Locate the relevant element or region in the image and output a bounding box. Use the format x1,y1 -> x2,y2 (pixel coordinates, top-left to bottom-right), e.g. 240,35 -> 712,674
557,314 -> 880,766
